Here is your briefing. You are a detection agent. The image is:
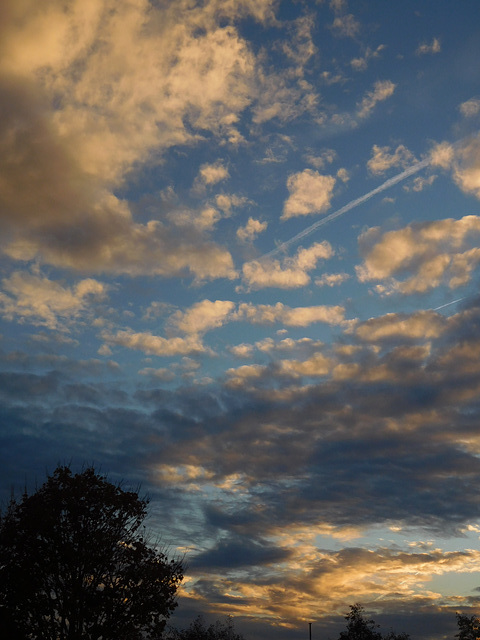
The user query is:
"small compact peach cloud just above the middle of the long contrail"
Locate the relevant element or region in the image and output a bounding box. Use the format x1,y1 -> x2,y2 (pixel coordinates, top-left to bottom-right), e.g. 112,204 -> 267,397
281,169 -> 335,220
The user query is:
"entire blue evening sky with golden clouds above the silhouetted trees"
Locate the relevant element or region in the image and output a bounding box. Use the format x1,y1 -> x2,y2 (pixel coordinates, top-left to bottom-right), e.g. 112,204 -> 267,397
0,0 -> 480,640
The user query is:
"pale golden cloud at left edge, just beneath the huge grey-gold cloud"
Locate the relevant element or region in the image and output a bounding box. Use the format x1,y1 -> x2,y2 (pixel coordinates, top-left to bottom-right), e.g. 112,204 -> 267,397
0,271 -> 108,331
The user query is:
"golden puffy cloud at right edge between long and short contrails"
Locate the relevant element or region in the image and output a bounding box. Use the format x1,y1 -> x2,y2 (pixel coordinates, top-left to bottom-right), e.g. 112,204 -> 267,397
356,216 -> 480,294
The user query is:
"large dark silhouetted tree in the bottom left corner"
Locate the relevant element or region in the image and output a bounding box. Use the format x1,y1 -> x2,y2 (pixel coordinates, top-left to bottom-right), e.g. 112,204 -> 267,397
0,467 -> 183,640
